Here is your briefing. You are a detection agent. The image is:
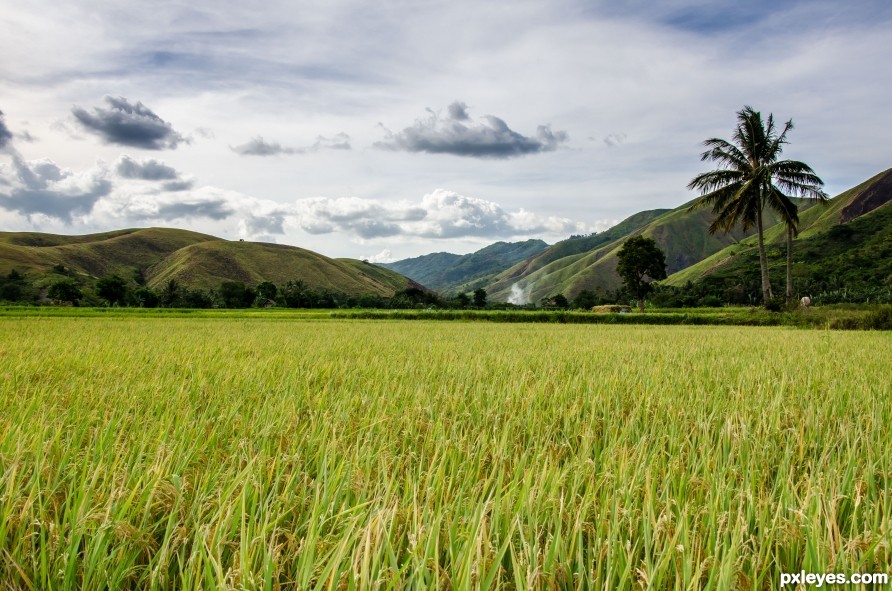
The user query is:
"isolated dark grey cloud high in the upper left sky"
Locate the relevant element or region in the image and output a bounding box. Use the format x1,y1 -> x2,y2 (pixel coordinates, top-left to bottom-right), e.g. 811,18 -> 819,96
71,96 -> 188,150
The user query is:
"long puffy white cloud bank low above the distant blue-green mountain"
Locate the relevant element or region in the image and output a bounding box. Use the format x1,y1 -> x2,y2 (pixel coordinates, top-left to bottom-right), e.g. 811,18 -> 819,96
288,189 -> 591,240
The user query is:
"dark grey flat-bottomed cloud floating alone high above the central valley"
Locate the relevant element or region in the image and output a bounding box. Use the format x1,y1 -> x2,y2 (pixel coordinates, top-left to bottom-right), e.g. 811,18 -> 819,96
375,102 -> 569,159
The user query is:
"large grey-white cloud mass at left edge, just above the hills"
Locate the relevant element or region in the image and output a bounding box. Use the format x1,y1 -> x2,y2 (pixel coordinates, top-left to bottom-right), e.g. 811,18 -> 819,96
0,154 -> 112,223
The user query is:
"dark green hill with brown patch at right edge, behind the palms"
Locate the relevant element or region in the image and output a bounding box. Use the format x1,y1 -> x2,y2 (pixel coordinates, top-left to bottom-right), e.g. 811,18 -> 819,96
664,169 -> 892,293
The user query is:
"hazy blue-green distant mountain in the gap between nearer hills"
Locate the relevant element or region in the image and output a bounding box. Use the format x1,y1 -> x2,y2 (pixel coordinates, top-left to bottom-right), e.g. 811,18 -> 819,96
380,240 -> 548,293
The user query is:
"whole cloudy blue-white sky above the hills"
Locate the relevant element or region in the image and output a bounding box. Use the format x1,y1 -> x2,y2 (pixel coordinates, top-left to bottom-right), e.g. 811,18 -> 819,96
0,0 -> 892,262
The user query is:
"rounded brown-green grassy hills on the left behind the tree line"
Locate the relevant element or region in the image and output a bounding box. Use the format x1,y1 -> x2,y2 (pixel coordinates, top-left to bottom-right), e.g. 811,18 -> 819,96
0,228 -> 414,296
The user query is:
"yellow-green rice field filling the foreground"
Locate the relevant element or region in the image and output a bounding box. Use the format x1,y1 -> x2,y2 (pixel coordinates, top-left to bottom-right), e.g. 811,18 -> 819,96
0,317 -> 892,590
